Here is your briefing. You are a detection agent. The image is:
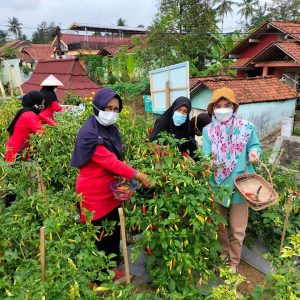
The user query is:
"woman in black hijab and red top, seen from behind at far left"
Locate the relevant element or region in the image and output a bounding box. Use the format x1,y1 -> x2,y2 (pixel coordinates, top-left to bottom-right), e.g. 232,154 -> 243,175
5,91 -> 54,162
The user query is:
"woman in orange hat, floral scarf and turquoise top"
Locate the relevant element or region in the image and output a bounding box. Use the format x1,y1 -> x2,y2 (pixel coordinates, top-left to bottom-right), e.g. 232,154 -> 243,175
203,87 -> 261,272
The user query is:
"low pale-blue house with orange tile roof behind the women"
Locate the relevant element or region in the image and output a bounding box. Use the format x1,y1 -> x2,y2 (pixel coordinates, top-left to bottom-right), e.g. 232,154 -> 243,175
190,76 -> 297,138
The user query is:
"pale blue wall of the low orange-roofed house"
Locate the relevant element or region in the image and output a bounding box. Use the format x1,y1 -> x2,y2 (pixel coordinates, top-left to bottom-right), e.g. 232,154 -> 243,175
191,89 -> 296,138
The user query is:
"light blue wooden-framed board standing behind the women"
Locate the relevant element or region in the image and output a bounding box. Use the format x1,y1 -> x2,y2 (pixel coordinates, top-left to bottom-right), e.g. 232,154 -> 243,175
149,61 -> 190,113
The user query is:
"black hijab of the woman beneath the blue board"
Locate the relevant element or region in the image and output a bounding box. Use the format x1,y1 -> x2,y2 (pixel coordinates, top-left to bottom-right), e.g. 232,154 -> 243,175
149,97 -> 197,153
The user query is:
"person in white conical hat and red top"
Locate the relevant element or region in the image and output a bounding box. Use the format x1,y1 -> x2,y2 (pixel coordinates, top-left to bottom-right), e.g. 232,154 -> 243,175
40,75 -> 63,120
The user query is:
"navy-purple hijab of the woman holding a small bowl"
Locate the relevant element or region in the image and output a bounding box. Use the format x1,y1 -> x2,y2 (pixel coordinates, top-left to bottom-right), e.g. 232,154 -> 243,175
71,88 -> 122,167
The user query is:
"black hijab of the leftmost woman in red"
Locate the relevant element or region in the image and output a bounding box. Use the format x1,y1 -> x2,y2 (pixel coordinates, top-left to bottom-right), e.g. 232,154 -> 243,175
7,91 -> 45,136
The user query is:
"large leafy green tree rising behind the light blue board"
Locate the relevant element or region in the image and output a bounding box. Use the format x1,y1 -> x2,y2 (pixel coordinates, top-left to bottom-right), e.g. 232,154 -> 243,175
143,0 -> 217,75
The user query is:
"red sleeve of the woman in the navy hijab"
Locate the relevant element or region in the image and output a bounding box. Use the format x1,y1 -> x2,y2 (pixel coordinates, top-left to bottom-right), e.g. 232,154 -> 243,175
92,145 -> 136,179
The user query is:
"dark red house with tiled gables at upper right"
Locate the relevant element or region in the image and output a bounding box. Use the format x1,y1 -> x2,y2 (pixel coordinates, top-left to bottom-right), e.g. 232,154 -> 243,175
225,21 -> 300,90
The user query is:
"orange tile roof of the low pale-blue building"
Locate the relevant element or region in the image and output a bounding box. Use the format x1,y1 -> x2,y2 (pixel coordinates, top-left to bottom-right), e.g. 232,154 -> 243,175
202,77 -> 296,103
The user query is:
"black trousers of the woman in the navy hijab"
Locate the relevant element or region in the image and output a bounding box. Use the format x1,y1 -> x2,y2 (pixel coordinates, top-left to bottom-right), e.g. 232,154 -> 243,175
92,207 -> 120,263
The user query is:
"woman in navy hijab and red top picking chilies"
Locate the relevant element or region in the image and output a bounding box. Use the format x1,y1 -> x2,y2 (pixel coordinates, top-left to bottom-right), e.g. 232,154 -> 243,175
71,88 -> 150,278
